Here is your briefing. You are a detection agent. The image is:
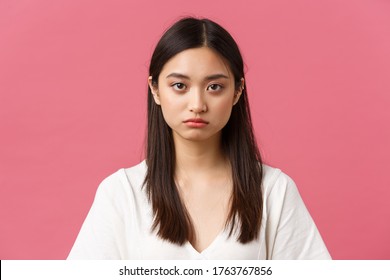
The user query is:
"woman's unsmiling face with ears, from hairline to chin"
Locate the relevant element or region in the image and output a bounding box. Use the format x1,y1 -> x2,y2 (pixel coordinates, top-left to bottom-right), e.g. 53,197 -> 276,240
149,47 -> 244,141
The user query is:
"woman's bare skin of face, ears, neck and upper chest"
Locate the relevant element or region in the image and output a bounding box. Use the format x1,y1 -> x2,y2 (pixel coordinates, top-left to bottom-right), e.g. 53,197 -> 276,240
148,47 -> 244,252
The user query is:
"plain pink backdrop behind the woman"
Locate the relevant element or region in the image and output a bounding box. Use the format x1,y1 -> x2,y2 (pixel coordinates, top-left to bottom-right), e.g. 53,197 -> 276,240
0,0 -> 390,259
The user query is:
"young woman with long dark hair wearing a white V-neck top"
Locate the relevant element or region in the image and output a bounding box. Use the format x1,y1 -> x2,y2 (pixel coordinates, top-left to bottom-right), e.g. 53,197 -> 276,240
68,18 -> 330,259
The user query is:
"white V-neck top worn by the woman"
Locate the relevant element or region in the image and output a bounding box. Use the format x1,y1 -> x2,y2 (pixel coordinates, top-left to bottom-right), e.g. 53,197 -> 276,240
68,161 -> 330,260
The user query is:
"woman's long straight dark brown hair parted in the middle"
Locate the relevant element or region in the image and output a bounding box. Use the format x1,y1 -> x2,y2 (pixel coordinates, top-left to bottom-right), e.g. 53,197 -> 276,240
144,18 -> 263,245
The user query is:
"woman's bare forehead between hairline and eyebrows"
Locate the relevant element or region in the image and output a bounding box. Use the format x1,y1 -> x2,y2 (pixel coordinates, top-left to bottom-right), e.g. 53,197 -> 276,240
160,47 -> 233,78
